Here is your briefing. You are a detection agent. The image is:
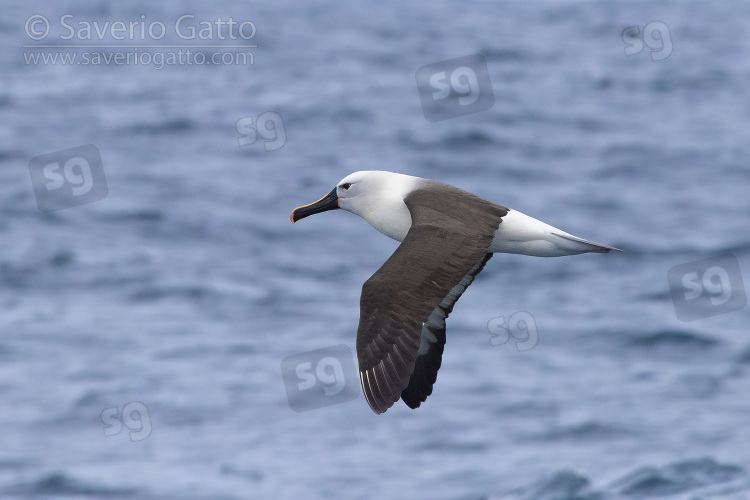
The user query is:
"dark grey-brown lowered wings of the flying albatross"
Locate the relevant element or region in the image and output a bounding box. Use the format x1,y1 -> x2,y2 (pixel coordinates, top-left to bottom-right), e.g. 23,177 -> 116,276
357,181 -> 508,413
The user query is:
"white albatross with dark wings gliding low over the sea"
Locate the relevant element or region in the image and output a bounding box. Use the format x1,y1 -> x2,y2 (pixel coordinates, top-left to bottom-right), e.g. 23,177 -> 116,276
289,171 -> 618,413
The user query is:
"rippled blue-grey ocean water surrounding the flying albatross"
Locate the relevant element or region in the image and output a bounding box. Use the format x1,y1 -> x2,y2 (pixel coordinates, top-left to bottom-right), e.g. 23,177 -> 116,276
0,0 -> 750,500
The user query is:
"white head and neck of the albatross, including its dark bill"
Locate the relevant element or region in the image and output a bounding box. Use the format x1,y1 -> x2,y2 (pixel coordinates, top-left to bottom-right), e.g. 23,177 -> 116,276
290,170 -> 420,241
